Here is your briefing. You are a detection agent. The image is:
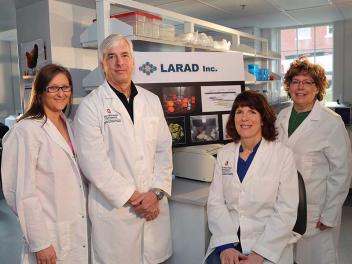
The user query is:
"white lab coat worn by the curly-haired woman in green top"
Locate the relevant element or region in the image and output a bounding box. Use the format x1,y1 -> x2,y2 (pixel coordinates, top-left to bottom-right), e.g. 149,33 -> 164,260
277,100 -> 352,264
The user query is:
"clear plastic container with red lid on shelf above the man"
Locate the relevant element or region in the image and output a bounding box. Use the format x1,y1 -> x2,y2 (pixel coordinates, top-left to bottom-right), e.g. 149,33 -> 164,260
111,11 -> 161,38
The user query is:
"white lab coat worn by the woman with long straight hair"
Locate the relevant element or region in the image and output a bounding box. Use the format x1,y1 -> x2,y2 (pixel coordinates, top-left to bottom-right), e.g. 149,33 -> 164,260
1,116 -> 89,264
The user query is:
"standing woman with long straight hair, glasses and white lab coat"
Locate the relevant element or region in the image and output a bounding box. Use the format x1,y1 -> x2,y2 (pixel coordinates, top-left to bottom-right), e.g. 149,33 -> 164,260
1,64 -> 88,264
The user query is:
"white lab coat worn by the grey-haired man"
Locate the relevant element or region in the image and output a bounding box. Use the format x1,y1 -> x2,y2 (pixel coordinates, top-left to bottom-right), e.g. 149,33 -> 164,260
74,82 -> 172,264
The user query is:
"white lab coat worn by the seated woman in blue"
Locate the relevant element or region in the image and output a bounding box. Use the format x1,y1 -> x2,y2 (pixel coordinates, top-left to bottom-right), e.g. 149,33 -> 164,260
207,138 -> 298,264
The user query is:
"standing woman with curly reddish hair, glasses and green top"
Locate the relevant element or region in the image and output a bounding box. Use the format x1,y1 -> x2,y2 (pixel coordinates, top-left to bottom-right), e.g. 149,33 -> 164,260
277,58 -> 352,264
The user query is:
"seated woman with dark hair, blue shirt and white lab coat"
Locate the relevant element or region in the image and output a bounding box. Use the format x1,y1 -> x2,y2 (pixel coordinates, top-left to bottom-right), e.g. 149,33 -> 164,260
206,91 -> 298,264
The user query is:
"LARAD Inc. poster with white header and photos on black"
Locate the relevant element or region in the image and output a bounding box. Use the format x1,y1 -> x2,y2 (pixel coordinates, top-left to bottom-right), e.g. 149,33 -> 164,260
133,52 -> 244,147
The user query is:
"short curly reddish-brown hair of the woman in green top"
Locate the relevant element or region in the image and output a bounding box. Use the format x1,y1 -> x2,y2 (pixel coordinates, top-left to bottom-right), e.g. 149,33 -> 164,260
284,57 -> 329,101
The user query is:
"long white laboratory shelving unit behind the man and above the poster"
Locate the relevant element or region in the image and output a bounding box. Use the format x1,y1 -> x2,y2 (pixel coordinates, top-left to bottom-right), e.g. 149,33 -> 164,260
80,0 -> 281,96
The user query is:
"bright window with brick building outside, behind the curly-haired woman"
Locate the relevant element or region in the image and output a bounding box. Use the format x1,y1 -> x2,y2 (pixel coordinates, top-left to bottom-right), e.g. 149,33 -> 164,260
281,25 -> 334,101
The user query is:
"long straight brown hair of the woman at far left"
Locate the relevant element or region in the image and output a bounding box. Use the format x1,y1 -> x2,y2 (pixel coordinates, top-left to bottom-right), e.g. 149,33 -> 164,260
18,64 -> 73,122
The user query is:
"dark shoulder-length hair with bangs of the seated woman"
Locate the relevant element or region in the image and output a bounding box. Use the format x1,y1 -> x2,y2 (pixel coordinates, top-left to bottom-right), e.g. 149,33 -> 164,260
226,91 -> 277,143
